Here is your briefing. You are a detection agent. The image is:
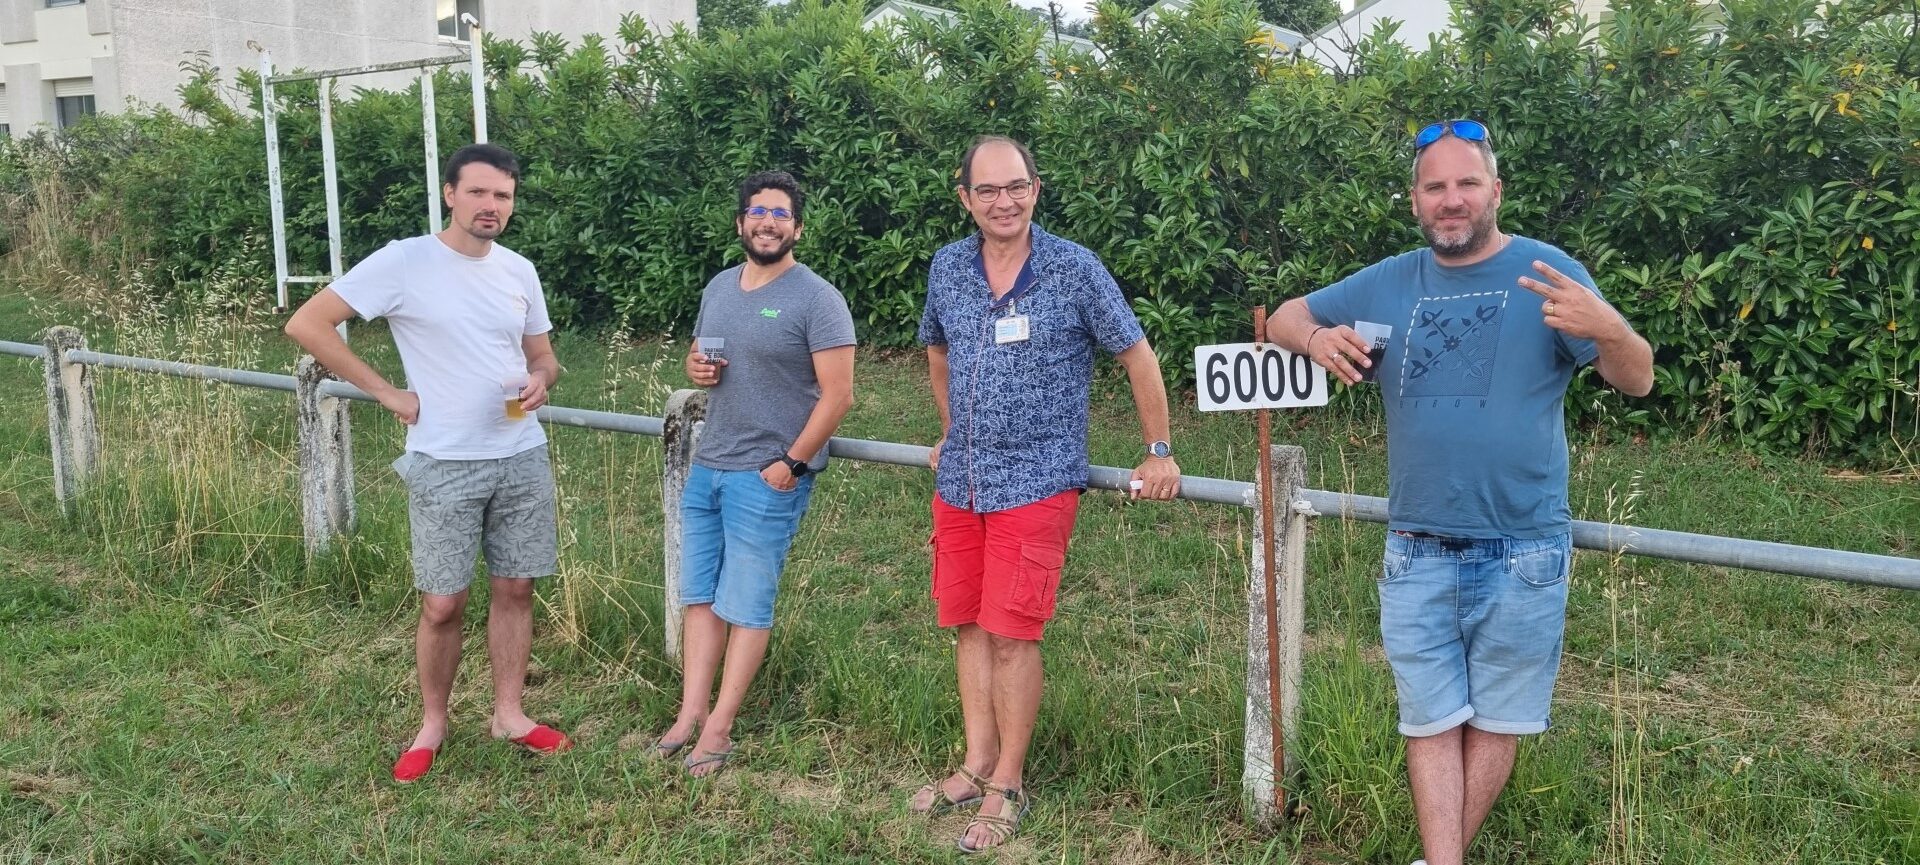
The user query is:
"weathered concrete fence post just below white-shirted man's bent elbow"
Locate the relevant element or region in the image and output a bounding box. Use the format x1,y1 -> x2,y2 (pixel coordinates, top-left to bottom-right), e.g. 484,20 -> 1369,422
294,355 -> 355,554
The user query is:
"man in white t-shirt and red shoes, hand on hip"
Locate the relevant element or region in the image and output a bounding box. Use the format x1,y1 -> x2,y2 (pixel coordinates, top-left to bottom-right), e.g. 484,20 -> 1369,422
286,144 -> 572,784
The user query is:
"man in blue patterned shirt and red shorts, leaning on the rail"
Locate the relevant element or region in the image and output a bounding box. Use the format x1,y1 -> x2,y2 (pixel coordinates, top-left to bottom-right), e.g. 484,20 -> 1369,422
912,136 -> 1181,853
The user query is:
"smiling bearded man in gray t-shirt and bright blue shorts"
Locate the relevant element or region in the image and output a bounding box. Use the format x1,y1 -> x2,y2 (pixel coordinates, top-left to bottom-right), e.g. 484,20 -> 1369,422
655,171 -> 854,777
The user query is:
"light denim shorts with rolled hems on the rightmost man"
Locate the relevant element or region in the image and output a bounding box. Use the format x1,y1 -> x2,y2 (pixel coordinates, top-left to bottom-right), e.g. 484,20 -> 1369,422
1380,531 -> 1572,736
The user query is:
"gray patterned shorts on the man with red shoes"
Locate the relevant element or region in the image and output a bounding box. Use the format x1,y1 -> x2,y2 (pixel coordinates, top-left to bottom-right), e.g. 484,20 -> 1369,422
394,445 -> 559,595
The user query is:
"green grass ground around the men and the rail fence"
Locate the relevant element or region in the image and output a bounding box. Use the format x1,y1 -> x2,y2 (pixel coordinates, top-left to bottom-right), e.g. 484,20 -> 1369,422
0,288 -> 1920,865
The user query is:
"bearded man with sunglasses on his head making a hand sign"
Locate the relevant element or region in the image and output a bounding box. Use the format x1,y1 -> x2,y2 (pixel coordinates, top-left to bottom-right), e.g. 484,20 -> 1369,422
1267,121 -> 1653,865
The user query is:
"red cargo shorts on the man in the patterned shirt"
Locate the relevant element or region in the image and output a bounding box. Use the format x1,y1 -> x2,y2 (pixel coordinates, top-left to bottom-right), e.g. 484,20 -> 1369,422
933,489 -> 1079,641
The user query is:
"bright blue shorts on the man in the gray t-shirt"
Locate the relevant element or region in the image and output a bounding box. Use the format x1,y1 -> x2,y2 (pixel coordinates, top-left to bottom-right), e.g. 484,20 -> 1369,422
680,466 -> 814,629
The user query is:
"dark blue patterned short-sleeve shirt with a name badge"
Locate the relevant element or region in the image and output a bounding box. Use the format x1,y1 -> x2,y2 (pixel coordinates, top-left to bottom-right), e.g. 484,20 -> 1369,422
920,224 -> 1146,514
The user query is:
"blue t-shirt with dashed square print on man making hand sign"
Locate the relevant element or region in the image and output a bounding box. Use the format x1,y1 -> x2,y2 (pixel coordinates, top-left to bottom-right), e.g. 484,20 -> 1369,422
1308,236 -> 1599,537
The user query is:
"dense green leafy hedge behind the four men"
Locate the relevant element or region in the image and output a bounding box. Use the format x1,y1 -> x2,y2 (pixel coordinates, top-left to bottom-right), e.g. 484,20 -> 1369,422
0,0 -> 1920,456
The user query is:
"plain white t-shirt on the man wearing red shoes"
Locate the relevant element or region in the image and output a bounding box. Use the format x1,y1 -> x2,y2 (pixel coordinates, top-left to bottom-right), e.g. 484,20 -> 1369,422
332,234 -> 553,460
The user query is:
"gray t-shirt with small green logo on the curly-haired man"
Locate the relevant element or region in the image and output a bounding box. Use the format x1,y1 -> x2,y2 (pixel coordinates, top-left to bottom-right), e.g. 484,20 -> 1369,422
693,265 -> 854,472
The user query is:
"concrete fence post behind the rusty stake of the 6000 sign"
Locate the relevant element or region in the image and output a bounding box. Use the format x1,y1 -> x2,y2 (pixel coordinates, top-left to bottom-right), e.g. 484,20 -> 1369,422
1240,445 -> 1311,829
